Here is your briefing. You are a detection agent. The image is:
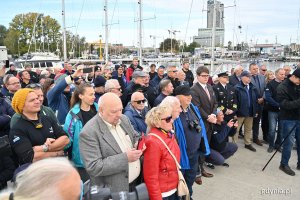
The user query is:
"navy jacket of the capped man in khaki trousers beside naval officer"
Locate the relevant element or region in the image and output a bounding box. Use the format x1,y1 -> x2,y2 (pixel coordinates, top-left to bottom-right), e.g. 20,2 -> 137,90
235,82 -> 259,117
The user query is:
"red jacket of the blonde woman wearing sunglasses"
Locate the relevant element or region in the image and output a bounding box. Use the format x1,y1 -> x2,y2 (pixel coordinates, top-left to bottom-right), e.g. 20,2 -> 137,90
143,128 -> 180,200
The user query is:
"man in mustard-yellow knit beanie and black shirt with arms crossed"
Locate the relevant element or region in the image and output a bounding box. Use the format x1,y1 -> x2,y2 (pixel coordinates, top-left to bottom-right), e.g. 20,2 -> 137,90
9,88 -> 70,165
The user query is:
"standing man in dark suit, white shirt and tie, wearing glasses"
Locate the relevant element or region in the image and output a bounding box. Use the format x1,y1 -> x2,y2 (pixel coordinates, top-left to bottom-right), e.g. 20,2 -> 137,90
191,67 -> 218,180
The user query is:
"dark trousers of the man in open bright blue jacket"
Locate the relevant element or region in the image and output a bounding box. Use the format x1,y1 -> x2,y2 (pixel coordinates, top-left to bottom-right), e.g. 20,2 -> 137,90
181,153 -> 199,196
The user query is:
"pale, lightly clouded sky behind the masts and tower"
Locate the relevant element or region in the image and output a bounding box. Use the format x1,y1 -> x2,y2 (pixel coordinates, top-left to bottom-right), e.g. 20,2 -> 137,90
0,0 -> 300,47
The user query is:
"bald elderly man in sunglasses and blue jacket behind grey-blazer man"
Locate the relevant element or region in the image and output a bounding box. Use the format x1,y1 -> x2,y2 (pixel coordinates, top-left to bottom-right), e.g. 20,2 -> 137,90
124,92 -> 148,135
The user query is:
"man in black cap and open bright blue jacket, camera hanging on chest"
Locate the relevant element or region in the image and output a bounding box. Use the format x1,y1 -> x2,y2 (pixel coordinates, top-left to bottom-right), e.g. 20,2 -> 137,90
174,85 -> 210,196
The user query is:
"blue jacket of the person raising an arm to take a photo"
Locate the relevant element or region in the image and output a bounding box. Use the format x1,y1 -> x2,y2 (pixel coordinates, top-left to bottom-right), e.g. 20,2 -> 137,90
47,76 -> 72,125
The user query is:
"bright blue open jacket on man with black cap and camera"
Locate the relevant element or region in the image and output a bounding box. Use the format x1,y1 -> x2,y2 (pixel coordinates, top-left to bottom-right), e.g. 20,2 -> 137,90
174,103 -> 210,169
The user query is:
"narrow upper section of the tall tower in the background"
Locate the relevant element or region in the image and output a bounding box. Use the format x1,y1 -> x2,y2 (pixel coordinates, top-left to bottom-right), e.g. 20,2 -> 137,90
207,0 -> 224,28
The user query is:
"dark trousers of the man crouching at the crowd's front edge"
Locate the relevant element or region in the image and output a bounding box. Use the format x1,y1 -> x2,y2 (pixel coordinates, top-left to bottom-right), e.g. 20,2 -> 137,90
206,142 -> 238,165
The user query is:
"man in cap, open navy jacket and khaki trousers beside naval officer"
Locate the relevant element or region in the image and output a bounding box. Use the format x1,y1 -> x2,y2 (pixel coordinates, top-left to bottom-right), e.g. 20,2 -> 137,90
233,71 -> 258,152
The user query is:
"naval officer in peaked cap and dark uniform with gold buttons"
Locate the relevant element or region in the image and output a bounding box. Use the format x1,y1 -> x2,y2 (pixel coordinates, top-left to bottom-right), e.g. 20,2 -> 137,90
213,72 -> 237,122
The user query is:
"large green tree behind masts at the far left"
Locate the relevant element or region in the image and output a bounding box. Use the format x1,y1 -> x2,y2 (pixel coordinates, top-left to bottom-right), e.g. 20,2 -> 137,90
4,13 -> 61,54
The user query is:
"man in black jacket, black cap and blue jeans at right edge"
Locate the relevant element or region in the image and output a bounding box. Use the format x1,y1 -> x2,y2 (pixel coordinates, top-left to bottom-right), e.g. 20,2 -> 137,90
277,68 -> 300,176
